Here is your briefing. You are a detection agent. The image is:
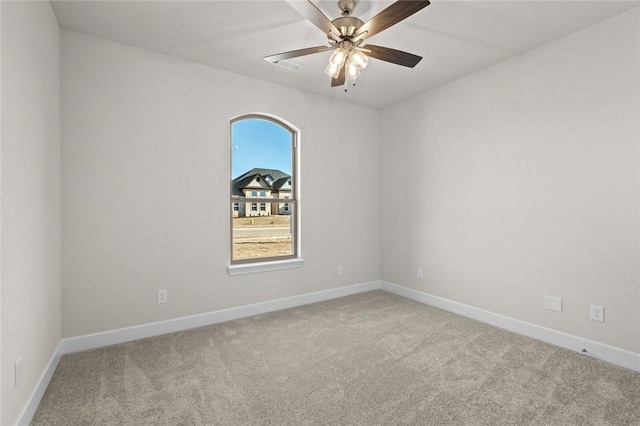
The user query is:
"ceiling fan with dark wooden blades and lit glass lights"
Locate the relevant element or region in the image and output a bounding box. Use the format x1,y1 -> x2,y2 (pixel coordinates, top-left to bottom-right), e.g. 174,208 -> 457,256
264,0 -> 429,90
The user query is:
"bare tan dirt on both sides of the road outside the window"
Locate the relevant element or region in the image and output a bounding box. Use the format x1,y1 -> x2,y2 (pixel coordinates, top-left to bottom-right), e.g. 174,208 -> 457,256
233,215 -> 292,260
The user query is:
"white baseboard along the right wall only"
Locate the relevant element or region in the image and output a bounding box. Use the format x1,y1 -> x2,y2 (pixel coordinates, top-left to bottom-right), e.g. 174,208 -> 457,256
380,281 -> 640,371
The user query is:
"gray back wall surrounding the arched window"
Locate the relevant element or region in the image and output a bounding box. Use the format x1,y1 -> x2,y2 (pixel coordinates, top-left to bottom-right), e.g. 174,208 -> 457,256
62,31 -> 380,337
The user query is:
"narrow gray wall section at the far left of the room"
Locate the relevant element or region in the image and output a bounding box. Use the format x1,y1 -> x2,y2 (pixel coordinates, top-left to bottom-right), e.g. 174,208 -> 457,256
0,1 -> 61,425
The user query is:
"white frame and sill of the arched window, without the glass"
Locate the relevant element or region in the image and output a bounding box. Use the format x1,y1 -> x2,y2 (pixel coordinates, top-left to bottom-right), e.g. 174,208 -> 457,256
227,113 -> 304,275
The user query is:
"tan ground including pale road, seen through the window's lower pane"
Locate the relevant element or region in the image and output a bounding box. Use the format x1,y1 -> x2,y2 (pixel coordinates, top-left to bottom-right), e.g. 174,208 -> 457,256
232,204 -> 295,261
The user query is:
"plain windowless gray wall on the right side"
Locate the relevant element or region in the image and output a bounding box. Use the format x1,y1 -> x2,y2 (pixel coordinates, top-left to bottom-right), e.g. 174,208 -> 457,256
381,9 -> 640,353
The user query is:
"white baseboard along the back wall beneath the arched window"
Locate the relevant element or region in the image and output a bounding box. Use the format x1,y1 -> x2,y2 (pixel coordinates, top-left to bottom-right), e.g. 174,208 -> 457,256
62,281 -> 380,355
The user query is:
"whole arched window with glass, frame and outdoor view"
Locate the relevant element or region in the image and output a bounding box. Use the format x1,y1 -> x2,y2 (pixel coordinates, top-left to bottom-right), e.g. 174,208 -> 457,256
229,114 -> 300,274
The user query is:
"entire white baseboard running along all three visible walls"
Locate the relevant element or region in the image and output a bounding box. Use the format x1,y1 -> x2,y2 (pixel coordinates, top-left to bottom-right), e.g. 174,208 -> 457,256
16,281 -> 640,426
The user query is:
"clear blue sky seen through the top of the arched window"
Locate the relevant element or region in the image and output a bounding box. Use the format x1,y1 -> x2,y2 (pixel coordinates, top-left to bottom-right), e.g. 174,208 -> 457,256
231,118 -> 291,179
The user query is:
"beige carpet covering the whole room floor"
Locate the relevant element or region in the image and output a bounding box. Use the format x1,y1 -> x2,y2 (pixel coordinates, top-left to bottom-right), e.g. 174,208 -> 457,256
33,291 -> 640,425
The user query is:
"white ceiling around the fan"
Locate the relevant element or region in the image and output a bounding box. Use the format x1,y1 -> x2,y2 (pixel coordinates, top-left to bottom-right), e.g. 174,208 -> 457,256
52,0 -> 640,109
